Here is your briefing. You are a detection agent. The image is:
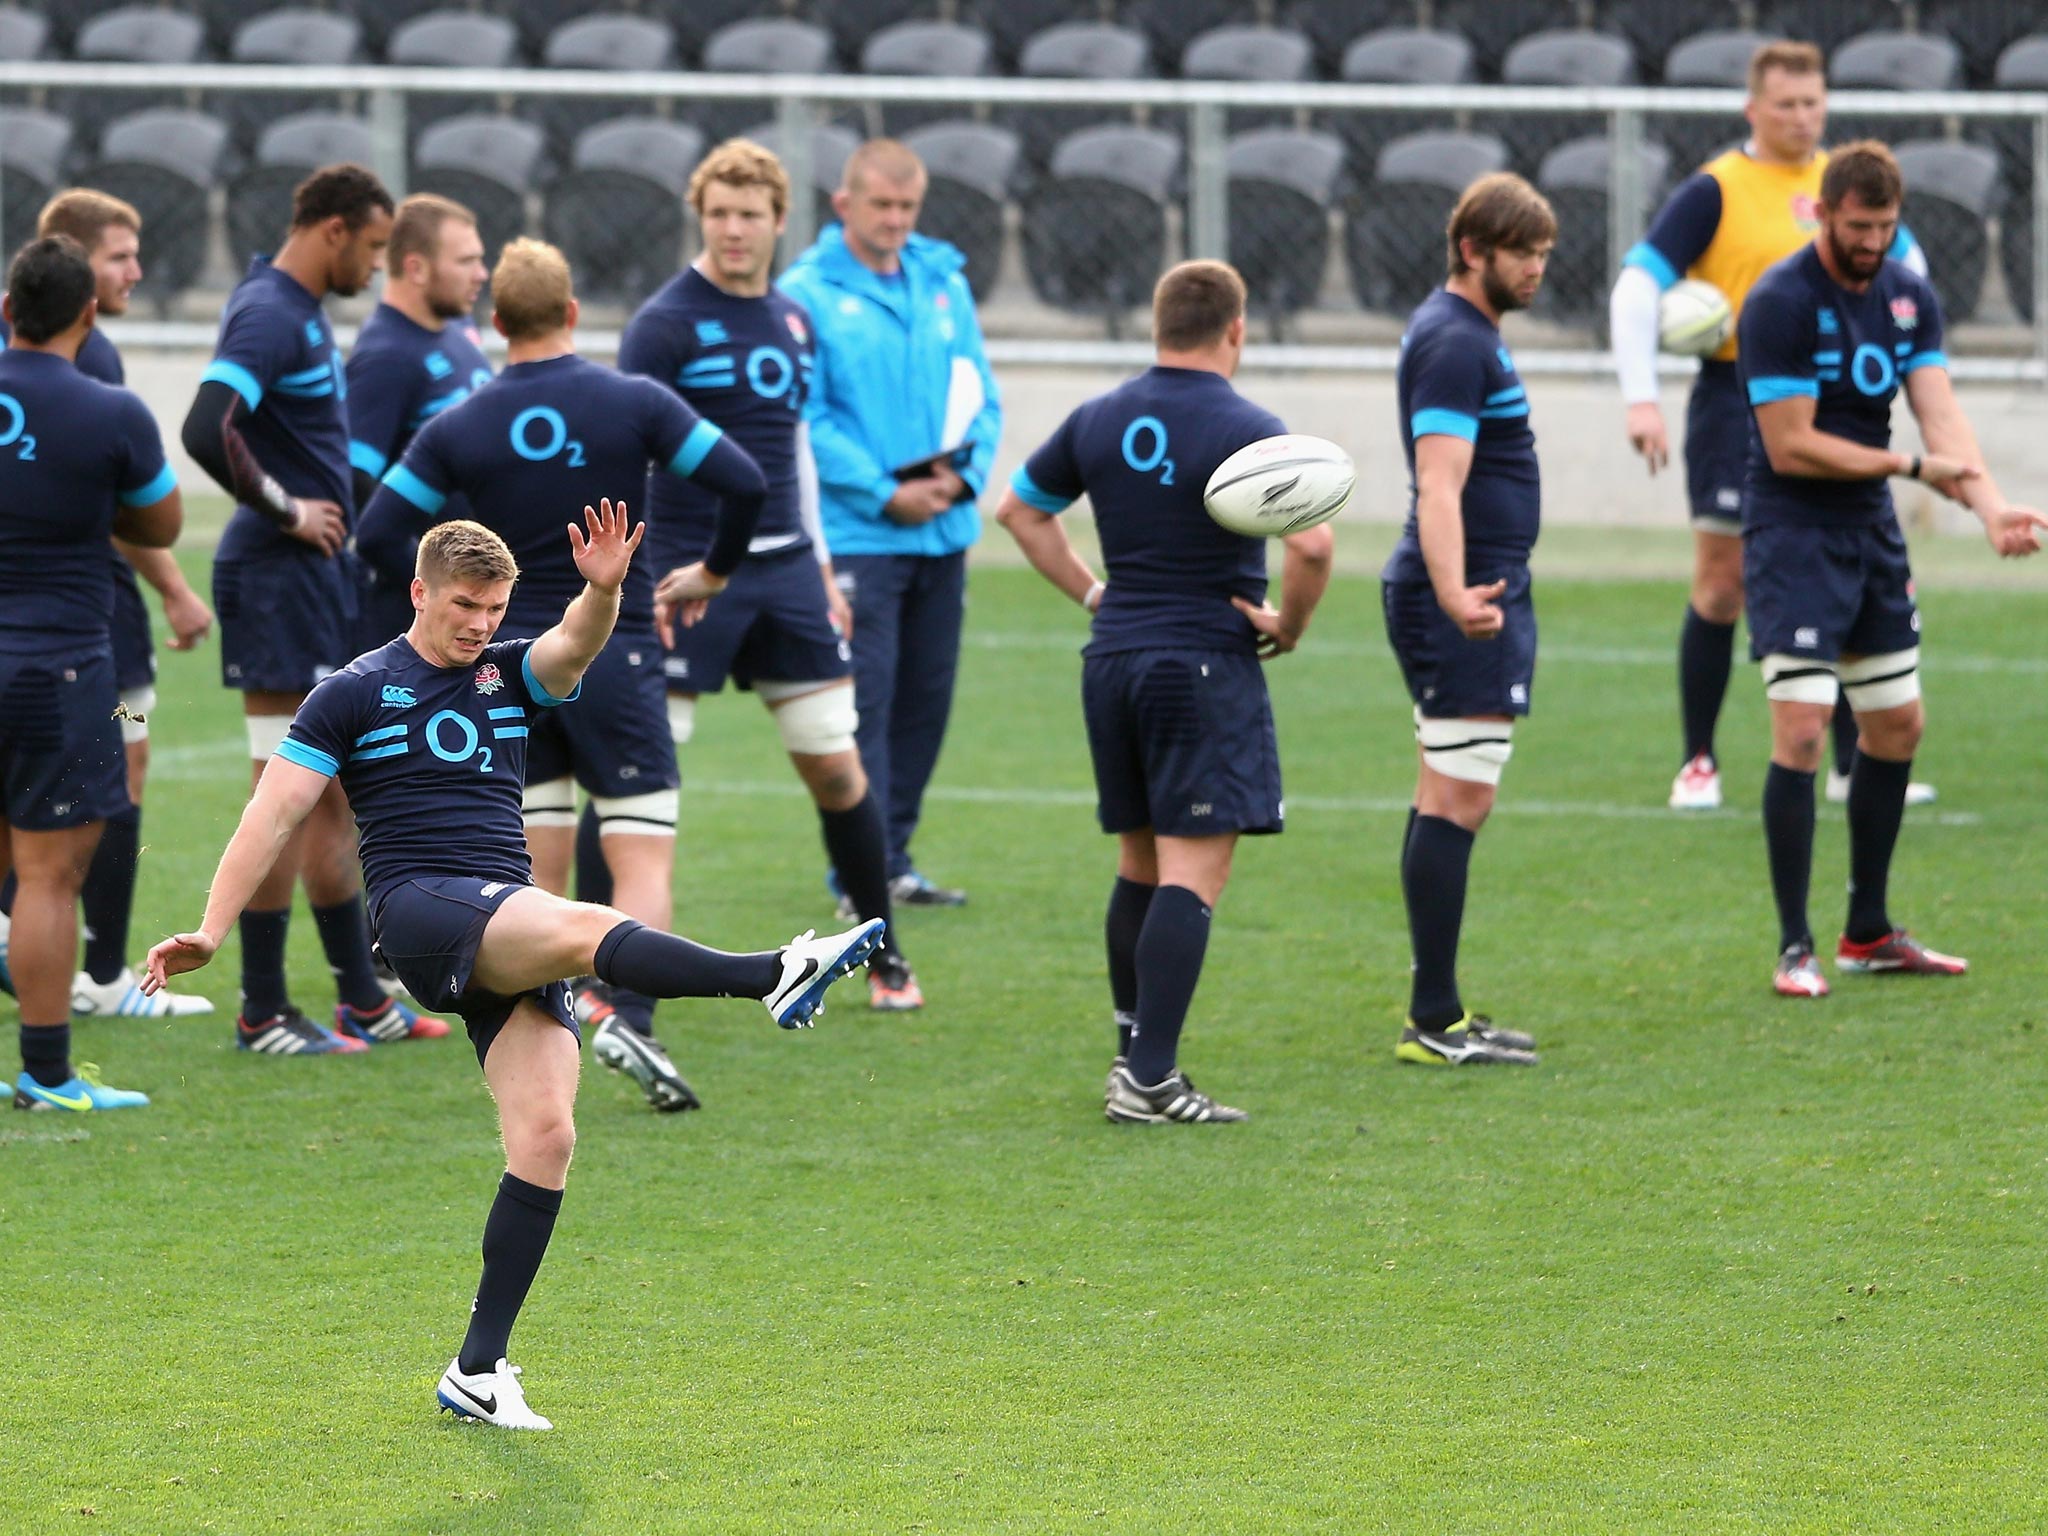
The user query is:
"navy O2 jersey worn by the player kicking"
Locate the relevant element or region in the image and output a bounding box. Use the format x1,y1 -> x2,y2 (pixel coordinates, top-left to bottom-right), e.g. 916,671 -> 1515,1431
276,635 -> 582,911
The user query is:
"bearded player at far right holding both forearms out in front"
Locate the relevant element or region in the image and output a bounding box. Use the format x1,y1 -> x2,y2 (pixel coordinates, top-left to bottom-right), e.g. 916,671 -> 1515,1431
1737,141 -> 2048,997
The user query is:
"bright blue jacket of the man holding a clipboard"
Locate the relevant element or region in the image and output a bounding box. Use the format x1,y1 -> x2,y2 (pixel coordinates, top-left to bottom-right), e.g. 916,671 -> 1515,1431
778,223 -> 1004,555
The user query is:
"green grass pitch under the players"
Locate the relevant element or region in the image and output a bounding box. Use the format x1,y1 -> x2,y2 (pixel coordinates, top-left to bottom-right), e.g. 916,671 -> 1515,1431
0,530 -> 2048,1536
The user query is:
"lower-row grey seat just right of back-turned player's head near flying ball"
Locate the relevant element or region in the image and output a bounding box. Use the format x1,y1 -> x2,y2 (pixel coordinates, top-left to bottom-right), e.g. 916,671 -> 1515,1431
1225,129 -> 1343,338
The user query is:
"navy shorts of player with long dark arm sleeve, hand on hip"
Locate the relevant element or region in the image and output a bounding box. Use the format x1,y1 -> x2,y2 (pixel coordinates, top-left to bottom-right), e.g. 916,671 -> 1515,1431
213,545 -> 360,694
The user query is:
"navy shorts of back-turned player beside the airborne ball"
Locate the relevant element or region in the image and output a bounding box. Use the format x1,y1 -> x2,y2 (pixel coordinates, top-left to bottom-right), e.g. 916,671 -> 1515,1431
1081,649 -> 1284,838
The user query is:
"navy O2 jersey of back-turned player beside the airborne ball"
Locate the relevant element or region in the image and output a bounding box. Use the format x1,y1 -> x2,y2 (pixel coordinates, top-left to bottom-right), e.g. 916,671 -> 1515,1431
1010,367 -> 1286,655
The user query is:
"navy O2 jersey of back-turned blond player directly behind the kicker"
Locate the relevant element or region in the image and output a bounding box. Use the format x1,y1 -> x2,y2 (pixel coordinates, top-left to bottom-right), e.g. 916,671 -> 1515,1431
358,354 -> 723,633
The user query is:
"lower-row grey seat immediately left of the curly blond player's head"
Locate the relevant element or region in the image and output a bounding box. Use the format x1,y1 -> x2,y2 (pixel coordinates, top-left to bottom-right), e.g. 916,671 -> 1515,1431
543,117 -> 705,305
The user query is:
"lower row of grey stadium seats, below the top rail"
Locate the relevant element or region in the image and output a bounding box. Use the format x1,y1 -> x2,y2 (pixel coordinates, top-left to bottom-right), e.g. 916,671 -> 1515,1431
0,111 -> 2032,330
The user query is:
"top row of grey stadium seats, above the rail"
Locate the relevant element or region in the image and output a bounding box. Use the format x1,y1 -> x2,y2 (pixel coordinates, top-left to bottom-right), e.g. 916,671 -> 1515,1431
0,0 -> 2048,90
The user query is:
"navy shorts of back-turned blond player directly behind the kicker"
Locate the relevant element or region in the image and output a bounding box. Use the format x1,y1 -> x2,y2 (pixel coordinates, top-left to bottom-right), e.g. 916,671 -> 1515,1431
526,626 -> 675,799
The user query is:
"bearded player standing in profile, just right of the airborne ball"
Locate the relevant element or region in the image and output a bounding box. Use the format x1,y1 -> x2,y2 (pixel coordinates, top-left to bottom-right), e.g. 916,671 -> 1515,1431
1380,172 -> 1556,1067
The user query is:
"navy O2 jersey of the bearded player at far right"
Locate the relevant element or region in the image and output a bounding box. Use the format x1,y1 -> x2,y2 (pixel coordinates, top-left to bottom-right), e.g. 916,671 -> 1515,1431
1735,246 -> 1948,528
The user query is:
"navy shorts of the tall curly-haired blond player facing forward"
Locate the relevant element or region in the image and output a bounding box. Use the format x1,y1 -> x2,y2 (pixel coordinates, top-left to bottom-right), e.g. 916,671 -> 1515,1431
666,547 -> 854,694
